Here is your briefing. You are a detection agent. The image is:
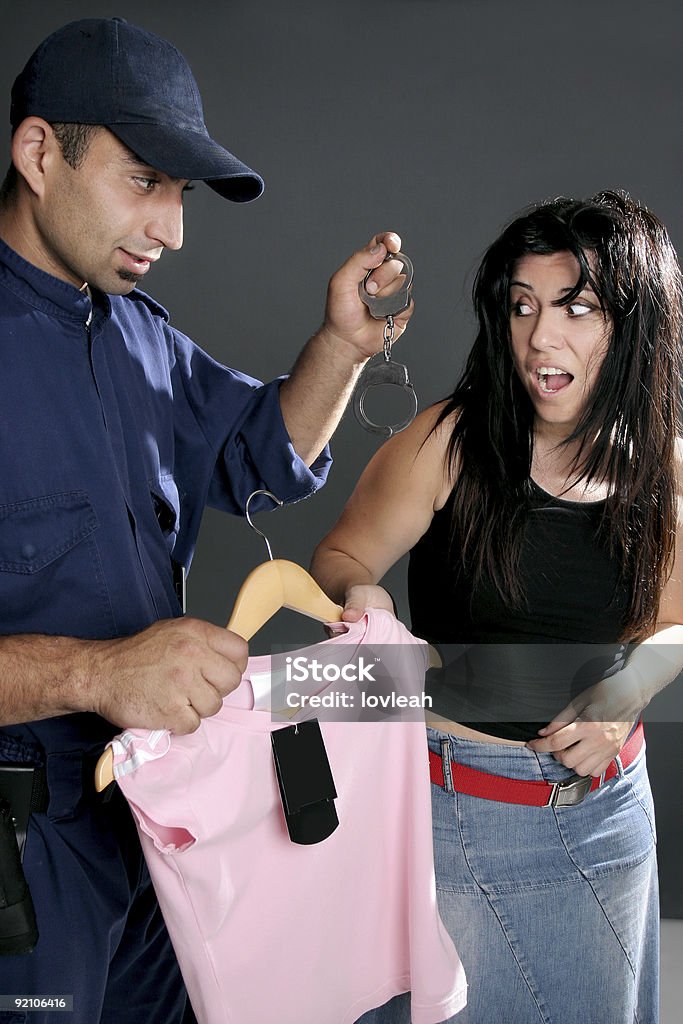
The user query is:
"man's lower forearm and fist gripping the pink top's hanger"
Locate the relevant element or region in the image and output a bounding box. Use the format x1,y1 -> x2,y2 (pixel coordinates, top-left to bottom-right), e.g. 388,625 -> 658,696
0,616 -> 248,733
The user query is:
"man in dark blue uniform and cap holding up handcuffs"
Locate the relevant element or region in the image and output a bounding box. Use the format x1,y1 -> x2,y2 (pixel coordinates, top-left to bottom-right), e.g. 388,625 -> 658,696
0,18 -> 408,1024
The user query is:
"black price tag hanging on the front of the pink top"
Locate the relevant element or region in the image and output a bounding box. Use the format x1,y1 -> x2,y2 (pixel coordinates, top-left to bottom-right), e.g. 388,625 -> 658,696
270,718 -> 339,846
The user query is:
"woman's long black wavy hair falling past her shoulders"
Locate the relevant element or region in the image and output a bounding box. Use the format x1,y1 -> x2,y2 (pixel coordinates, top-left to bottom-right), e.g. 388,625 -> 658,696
438,191 -> 683,640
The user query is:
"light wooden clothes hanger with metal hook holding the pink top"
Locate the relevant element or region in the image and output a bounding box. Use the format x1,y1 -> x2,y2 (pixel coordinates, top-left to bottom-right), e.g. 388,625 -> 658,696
95,490 -> 441,793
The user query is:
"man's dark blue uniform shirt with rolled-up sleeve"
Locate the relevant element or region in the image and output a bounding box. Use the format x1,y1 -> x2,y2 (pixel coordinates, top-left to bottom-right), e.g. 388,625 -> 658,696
0,242 -> 331,750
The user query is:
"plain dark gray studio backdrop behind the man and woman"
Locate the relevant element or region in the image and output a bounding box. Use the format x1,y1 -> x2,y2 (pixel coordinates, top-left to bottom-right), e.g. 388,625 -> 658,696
0,0 -> 683,916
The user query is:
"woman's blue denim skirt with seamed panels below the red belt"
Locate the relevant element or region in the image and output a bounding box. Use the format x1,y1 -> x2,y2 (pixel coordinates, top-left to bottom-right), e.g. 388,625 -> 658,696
361,729 -> 659,1024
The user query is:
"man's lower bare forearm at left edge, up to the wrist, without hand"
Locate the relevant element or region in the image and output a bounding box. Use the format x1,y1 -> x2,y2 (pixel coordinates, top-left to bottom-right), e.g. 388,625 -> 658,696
0,635 -> 91,725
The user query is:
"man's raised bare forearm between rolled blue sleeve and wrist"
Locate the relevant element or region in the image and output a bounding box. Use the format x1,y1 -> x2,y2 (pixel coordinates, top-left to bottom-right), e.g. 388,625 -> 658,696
280,329 -> 367,466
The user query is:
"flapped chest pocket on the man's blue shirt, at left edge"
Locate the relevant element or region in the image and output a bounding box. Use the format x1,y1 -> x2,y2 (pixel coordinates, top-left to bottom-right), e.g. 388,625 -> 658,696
0,490 -> 114,636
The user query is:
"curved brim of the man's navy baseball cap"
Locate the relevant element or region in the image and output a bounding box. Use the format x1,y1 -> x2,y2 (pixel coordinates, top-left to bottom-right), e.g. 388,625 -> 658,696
106,123 -> 264,203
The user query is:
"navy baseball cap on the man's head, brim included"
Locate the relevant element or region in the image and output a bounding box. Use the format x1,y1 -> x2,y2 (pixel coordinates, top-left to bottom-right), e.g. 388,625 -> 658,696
9,17 -> 263,203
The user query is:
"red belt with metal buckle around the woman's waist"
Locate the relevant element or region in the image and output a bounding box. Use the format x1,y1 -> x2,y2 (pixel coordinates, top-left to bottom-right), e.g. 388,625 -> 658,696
429,722 -> 645,807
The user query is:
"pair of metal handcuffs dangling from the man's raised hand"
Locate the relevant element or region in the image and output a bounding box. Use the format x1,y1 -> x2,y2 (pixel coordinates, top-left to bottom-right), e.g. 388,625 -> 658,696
353,253 -> 418,437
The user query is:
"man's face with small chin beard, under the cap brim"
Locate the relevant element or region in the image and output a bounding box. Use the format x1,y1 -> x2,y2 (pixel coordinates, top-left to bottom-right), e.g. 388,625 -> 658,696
36,129 -> 187,295
